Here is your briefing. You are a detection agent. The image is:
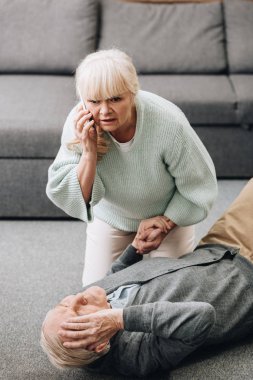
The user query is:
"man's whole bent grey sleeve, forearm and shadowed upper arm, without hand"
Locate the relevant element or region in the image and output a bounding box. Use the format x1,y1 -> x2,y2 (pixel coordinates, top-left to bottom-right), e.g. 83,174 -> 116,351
116,302 -> 215,376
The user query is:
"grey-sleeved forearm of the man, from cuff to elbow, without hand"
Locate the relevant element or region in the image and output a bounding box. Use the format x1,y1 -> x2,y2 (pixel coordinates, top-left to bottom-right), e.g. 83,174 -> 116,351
123,301 -> 215,344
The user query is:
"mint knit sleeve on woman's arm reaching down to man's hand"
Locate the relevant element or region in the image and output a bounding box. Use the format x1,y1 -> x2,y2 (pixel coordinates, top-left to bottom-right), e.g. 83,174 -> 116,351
164,118 -> 217,226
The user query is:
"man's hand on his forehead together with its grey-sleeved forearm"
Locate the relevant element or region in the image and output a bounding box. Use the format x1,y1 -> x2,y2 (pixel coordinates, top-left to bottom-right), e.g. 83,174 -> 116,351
60,301 -> 215,357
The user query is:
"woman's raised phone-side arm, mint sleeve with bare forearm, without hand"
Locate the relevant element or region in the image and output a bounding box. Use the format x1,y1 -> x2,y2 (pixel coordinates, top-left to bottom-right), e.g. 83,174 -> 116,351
46,107 -> 105,222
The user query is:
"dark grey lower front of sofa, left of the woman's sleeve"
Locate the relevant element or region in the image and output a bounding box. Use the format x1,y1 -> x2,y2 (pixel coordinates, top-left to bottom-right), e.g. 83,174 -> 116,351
0,158 -> 66,217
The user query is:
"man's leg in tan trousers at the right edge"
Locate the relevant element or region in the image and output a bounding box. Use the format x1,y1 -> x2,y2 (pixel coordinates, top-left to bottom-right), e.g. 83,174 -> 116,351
199,178 -> 253,262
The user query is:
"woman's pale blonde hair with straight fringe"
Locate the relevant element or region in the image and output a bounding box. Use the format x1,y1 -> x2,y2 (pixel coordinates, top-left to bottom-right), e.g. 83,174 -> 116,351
68,49 -> 139,159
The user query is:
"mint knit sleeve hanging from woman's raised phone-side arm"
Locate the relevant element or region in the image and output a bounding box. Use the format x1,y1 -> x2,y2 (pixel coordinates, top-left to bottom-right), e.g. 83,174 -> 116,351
46,108 -> 105,222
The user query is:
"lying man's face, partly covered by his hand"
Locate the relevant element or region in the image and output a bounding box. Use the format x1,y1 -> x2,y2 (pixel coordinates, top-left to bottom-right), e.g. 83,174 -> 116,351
43,286 -> 110,342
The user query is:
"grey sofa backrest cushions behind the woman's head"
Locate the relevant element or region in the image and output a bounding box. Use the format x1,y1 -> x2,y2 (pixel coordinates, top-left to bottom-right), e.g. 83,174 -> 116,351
0,0 -> 253,74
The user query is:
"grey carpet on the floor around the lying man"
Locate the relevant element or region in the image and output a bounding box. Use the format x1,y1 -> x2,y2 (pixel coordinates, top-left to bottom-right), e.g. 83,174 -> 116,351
0,180 -> 253,380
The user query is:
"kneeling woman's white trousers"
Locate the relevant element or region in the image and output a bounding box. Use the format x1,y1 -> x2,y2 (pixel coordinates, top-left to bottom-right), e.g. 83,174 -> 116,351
82,218 -> 195,286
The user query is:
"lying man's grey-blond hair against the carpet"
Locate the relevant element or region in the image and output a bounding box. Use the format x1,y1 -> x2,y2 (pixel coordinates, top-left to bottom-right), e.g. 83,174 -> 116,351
40,327 -> 110,369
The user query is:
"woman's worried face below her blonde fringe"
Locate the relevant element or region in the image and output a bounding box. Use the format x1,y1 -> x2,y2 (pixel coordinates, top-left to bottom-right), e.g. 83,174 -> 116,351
85,91 -> 136,134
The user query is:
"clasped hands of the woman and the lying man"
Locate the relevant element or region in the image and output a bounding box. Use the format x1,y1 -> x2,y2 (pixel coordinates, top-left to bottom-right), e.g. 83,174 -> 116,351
132,216 -> 176,254
